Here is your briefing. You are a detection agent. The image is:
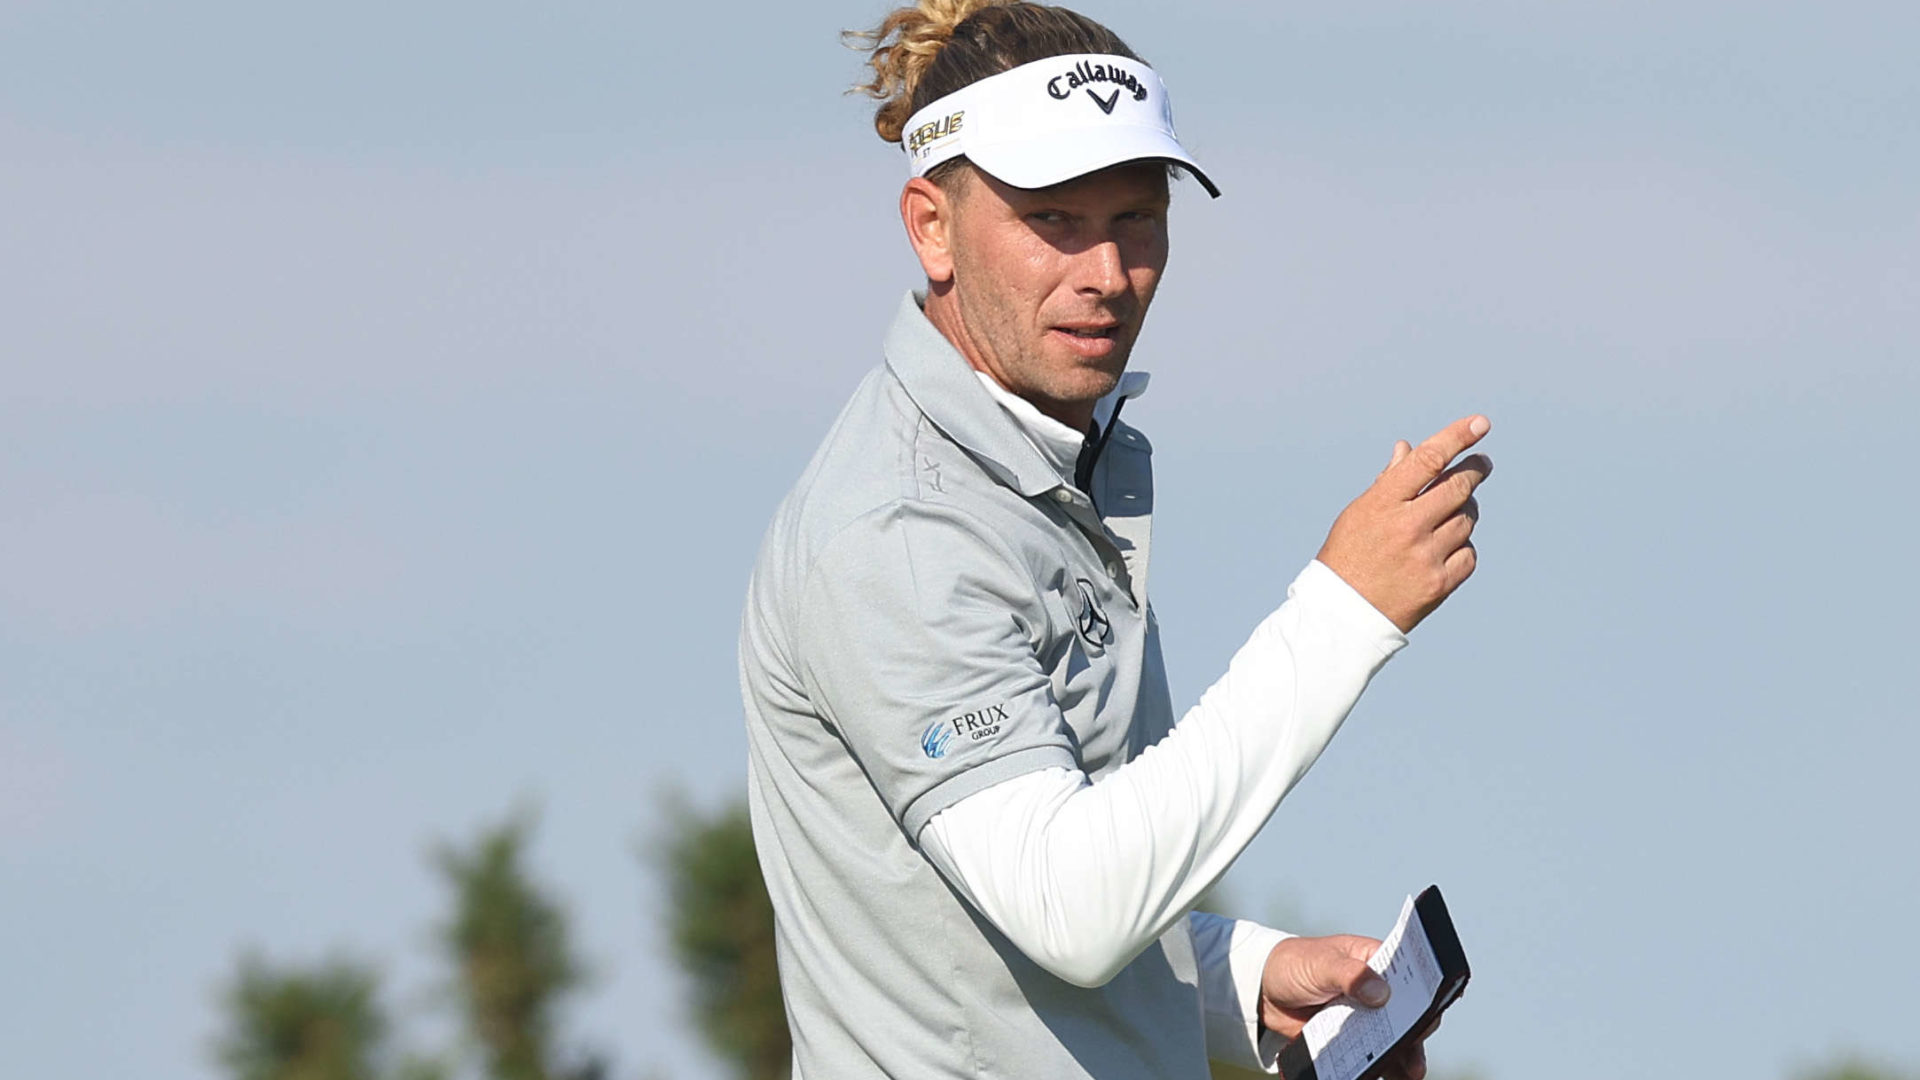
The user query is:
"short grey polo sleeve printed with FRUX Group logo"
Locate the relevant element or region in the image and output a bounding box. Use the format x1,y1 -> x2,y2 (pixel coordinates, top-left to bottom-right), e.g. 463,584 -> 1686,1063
797,502 -> 1077,836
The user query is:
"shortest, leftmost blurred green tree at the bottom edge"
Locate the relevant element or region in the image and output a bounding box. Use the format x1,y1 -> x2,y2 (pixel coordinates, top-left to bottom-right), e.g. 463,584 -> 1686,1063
215,953 -> 388,1080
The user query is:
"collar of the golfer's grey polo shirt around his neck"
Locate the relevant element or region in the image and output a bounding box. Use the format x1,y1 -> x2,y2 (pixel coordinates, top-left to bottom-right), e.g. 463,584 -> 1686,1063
885,290 -> 1148,496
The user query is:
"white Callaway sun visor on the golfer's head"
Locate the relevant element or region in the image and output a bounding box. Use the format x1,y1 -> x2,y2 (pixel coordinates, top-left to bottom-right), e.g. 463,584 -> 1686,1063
900,54 -> 1219,198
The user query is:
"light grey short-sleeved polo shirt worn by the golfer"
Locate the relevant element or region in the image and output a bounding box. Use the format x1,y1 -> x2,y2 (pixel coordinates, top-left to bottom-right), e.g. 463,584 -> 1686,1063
741,294 -> 1208,1080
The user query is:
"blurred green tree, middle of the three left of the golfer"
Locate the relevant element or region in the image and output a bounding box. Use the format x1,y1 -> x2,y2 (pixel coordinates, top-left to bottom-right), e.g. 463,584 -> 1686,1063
432,811 -> 607,1080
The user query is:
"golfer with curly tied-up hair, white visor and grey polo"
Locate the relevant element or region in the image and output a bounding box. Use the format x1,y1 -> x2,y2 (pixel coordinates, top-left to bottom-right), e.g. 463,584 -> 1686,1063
741,0 -> 1492,1080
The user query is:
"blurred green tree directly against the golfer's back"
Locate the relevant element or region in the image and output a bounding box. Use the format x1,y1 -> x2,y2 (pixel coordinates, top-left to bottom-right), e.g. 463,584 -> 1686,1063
659,799 -> 793,1080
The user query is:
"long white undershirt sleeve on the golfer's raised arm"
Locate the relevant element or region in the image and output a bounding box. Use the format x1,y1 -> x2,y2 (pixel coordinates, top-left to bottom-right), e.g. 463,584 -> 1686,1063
920,561 -> 1405,991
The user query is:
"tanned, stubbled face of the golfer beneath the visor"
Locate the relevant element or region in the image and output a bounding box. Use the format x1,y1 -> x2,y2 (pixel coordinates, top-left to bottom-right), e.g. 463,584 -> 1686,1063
902,161 -> 1167,429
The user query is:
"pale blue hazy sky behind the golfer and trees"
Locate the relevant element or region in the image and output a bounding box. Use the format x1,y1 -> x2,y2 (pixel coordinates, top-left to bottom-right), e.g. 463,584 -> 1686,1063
0,2 -> 1920,1080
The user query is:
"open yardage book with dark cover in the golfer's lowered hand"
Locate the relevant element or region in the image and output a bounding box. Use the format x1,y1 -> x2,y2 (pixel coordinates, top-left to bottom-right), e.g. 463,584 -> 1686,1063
1281,886 -> 1473,1080
